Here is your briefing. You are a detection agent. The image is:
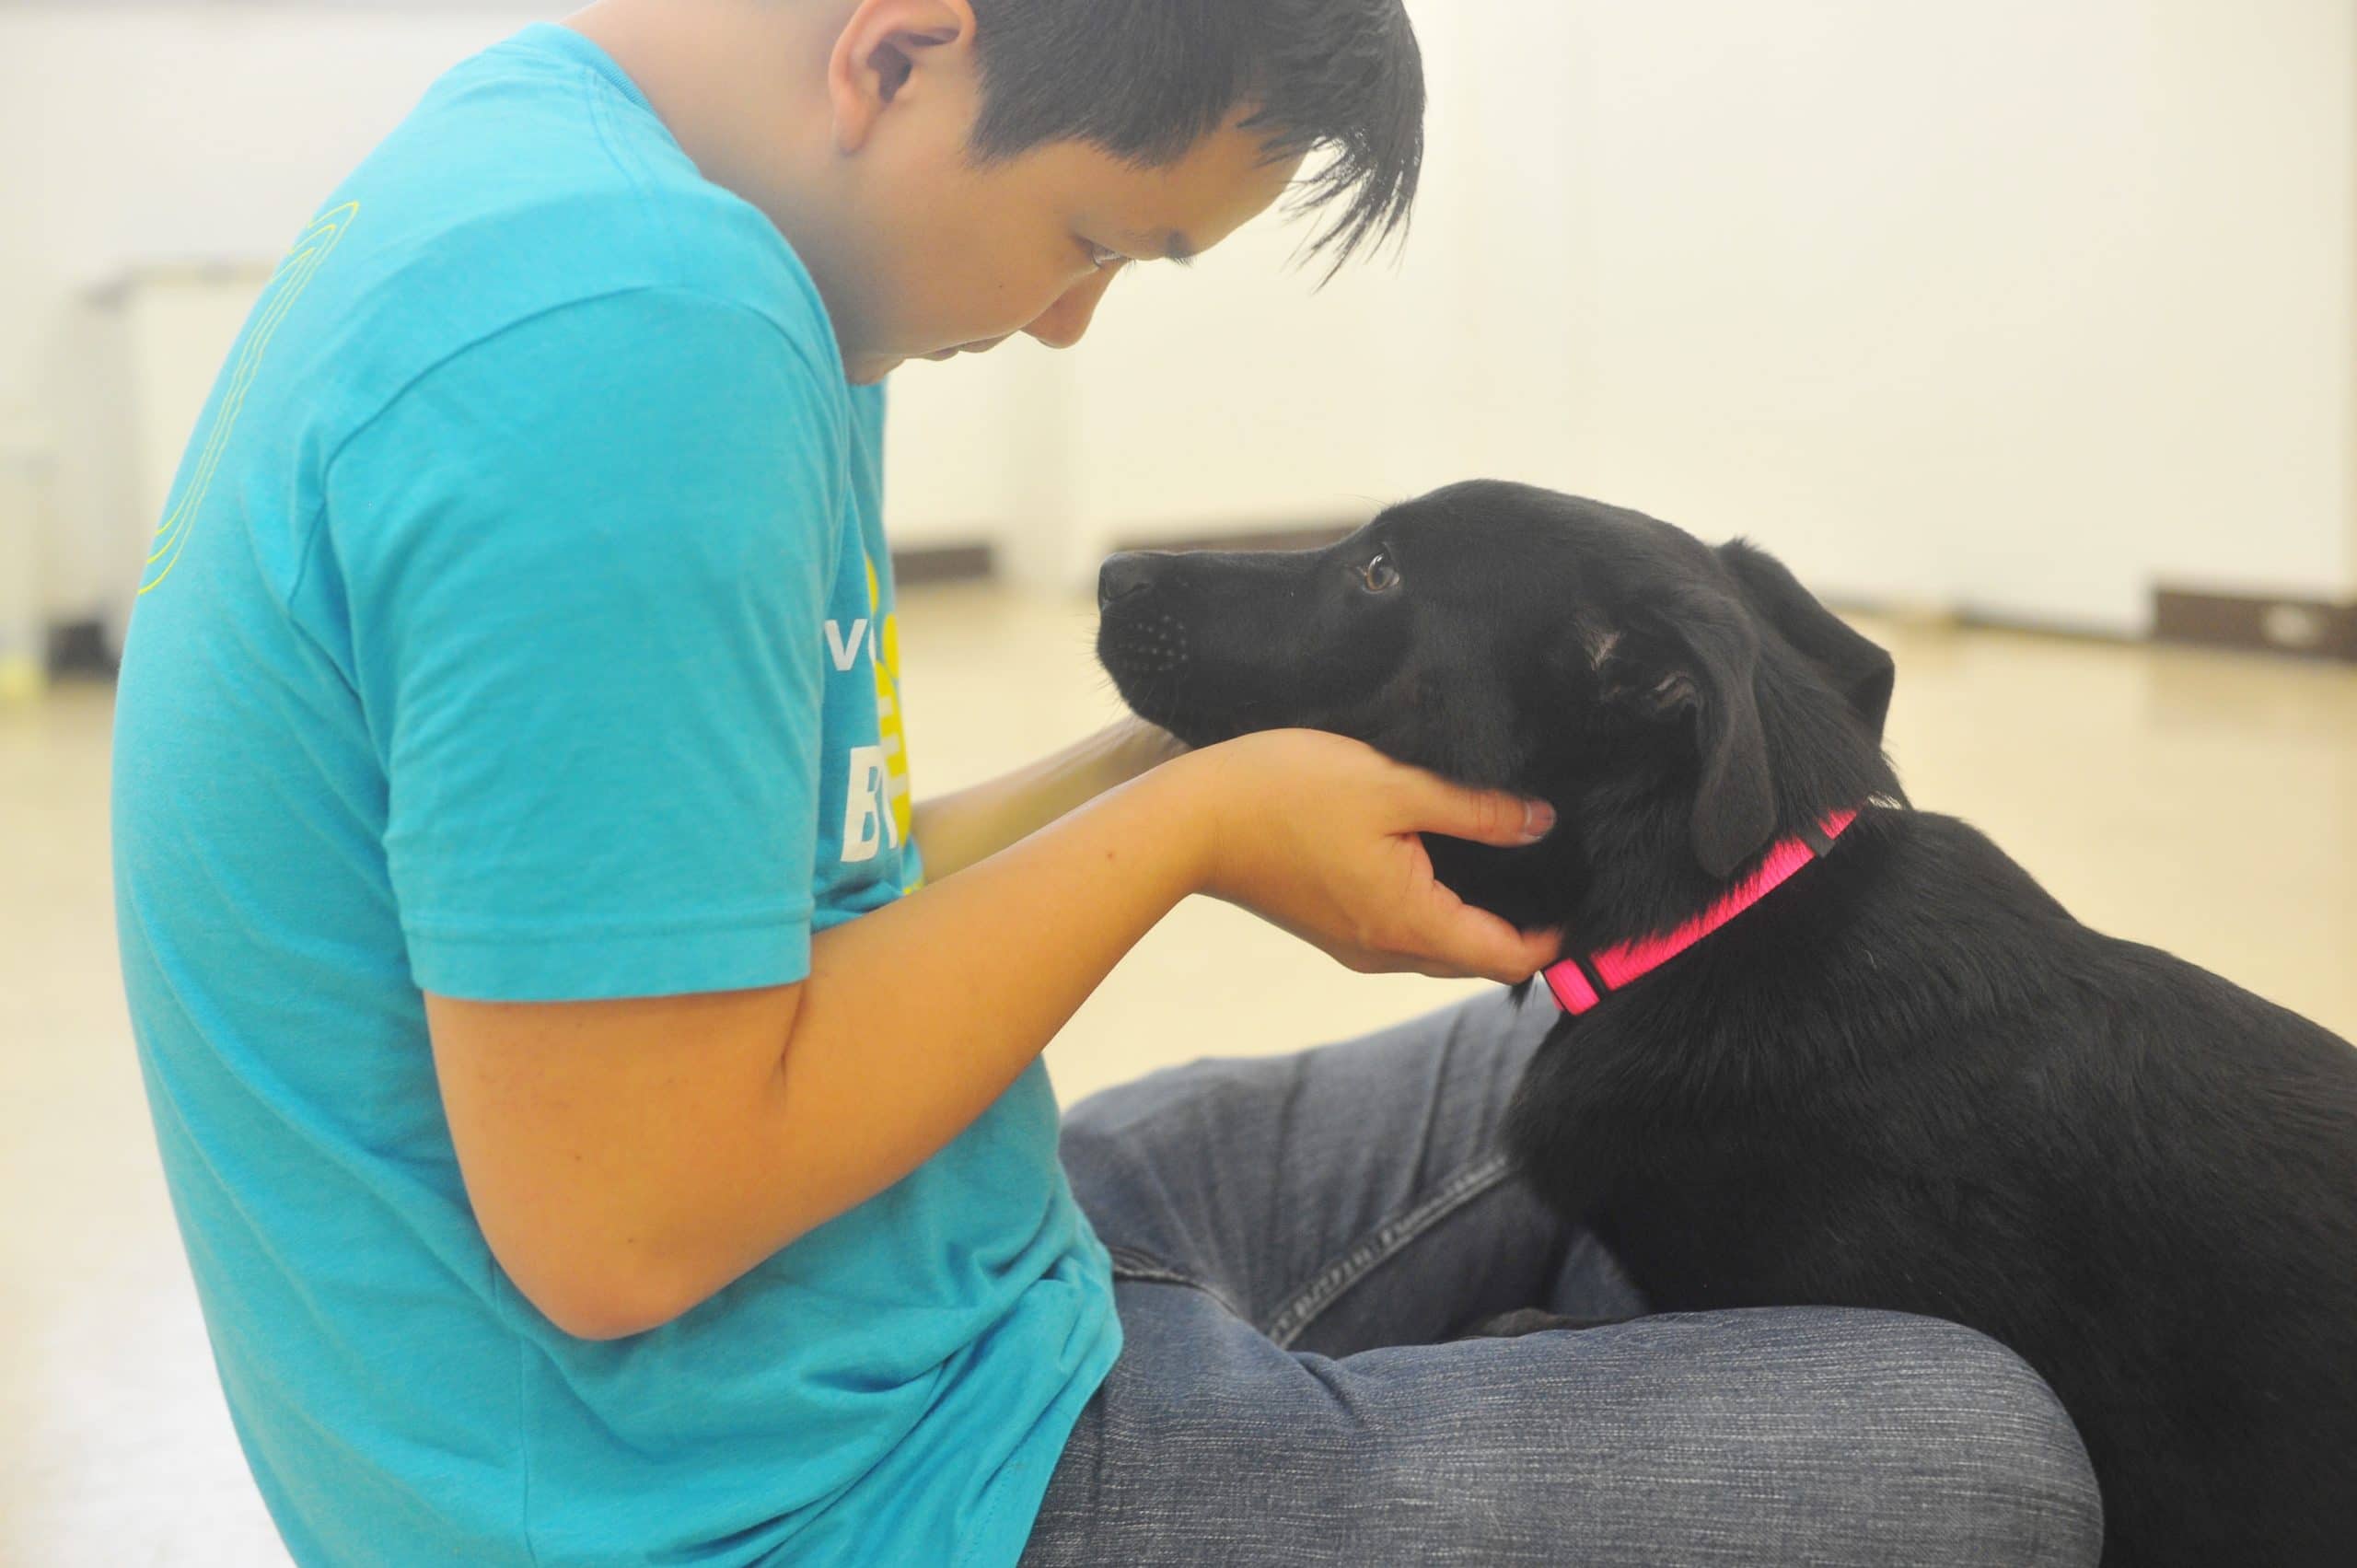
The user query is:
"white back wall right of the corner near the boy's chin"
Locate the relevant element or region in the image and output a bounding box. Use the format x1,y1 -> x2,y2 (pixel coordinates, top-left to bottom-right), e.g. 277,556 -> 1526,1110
1077,0 -> 2357,630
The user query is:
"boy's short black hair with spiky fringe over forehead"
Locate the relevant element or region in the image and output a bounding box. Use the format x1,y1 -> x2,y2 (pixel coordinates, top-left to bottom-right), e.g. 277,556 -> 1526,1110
973,0 -> 1423,266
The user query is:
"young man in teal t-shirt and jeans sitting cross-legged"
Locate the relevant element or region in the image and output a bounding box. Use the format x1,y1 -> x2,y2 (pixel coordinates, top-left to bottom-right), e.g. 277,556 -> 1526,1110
115,0 -> 2097,1563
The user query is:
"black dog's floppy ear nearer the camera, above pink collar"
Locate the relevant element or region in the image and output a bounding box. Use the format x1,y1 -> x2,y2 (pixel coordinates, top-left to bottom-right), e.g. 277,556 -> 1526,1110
1653,589 -> 1775,879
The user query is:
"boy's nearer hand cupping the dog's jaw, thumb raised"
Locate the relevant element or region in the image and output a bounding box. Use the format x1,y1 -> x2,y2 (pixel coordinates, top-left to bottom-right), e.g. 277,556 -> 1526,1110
1169,728 -> 1561,983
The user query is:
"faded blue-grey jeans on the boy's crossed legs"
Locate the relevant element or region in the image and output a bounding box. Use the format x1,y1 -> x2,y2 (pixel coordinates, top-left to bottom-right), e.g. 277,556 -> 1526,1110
1023,993 -> 2103,1568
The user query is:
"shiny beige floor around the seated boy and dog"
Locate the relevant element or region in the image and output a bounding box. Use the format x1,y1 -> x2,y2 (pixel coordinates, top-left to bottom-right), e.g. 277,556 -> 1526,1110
0,589 -> 2357,1568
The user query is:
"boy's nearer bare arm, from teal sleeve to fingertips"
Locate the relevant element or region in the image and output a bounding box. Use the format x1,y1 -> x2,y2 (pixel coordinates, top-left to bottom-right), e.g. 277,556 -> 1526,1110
426,731 -> 1556,1340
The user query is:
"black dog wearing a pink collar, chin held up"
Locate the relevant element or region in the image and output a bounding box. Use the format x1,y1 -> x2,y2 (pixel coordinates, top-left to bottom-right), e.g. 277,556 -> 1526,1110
1098,483 -> 2357,1568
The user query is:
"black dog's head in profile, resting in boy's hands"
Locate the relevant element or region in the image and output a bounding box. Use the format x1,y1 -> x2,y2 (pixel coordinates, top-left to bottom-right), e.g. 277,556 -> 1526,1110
1096,481 -> 1898,929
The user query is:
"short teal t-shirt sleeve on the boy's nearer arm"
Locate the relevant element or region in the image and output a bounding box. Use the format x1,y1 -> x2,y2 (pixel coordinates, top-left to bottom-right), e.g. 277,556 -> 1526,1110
328,290 -> 849,1002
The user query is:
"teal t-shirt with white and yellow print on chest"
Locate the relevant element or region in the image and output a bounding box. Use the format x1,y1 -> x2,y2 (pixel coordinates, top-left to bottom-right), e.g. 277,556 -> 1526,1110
113,26 -> 1120,1568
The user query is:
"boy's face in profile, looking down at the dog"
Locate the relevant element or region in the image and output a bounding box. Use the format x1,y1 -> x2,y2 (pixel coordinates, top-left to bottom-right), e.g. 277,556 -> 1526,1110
830,92 -> 1301,382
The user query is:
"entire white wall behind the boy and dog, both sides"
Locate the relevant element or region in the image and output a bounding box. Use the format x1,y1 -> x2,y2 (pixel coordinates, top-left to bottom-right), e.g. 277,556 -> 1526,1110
0,0 -> 2357,630
